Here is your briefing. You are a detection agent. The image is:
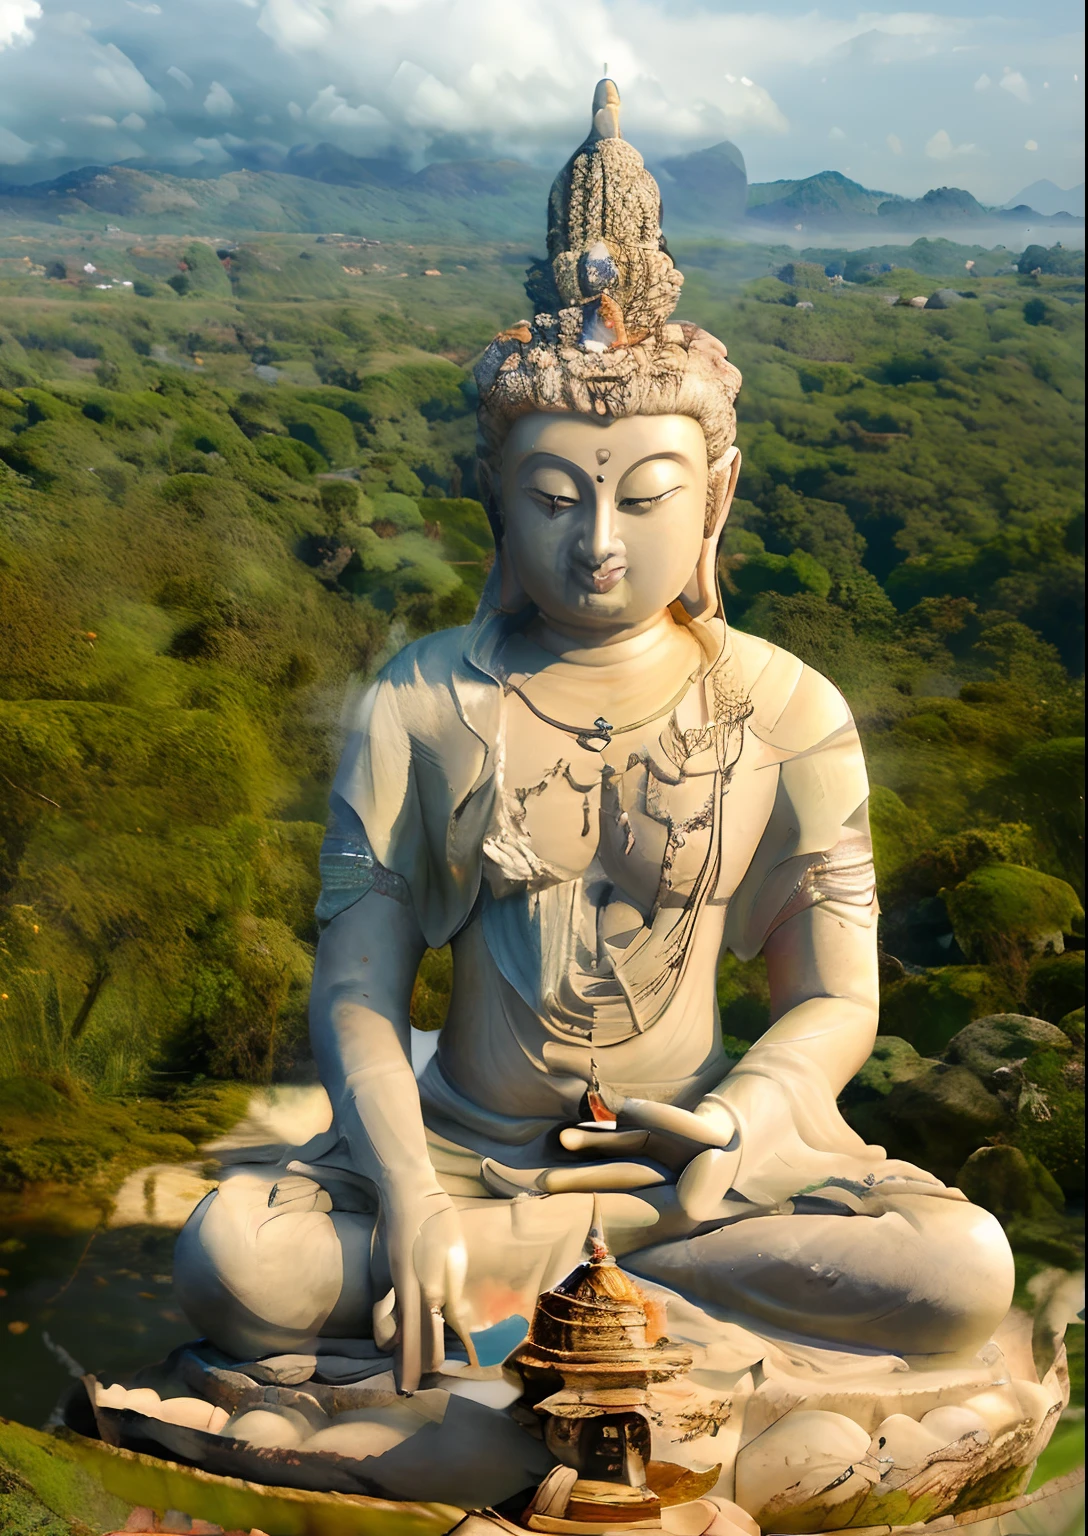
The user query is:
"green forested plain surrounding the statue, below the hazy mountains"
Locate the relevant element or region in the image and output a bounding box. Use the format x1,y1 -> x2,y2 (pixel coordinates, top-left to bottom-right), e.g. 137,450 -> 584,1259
0,223 -> 1083,1314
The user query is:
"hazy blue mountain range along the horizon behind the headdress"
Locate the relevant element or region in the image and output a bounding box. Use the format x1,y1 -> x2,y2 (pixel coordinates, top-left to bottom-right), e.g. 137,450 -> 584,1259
0,140 -> 1083,241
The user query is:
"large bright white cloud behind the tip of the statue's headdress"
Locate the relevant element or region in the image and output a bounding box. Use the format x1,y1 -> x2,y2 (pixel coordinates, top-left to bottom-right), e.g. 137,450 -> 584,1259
258,0 -> 792,158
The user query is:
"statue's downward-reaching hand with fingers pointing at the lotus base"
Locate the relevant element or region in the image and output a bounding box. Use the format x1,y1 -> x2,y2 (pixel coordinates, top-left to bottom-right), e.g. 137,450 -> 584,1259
373,1189 -> 476,1392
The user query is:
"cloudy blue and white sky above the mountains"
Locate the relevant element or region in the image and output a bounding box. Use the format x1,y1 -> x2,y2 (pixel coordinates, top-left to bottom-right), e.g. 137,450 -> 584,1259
0,0 -> 1083,203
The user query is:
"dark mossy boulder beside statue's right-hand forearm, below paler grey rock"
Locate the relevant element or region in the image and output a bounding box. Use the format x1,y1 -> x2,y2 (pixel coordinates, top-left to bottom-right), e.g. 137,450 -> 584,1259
879,1063 -> 1011,1183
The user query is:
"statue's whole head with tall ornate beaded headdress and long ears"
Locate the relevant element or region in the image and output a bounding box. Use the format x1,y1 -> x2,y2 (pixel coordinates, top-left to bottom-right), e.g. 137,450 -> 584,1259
476,80 -> 741,628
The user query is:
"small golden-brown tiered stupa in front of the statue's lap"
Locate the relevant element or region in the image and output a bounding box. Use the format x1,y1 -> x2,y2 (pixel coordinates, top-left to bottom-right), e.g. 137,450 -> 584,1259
510,1206 -> 706,1536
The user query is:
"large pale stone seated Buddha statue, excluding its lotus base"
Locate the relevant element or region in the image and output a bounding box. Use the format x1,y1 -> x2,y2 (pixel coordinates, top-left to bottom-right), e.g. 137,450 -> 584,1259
175,81 -> 1057,1528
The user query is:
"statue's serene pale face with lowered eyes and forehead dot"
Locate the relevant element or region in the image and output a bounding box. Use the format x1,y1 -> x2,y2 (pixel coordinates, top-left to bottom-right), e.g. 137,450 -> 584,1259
503,412 -> 707,631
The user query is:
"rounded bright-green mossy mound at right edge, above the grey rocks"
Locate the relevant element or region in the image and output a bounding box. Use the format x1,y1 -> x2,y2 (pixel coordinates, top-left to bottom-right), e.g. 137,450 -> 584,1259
942,863 -> 1085,962
